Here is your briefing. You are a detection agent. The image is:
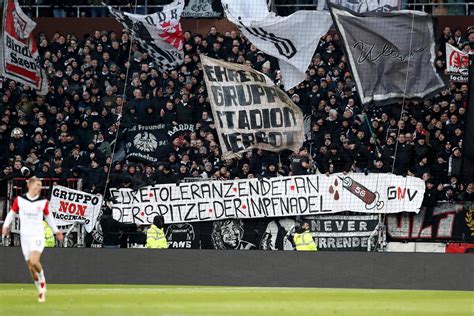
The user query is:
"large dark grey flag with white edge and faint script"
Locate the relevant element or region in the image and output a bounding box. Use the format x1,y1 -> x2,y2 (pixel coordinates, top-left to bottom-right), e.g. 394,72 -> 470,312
330,5 -> 444,105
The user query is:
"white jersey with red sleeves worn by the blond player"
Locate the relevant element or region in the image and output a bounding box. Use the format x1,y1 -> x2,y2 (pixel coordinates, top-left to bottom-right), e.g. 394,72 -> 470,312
11,194 -> 49,237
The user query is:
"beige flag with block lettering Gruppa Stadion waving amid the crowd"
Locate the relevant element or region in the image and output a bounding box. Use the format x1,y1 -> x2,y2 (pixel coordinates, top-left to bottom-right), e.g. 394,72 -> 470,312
201,55 -> 304,158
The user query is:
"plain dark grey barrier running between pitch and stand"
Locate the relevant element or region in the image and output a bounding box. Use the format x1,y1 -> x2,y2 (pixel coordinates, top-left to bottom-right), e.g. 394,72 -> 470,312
0,247 -> 474,291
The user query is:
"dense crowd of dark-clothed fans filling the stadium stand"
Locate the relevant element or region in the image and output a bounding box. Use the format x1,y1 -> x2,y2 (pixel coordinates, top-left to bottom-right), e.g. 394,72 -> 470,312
0,23 -> 474,205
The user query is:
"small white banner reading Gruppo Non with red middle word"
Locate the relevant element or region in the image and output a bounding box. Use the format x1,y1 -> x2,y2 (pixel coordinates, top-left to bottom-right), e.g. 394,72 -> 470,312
49,185 -> 102,233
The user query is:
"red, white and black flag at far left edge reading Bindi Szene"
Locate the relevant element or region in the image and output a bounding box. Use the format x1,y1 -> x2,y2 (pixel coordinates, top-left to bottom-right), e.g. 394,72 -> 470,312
0,0 -> 48,95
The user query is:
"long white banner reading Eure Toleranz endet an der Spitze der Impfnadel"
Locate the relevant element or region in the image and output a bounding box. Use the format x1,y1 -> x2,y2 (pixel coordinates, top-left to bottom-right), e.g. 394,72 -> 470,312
110,173 -> 425,224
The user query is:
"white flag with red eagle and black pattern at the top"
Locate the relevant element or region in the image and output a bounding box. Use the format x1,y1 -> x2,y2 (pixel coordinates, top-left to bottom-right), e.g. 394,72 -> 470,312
108,0 -> 184,71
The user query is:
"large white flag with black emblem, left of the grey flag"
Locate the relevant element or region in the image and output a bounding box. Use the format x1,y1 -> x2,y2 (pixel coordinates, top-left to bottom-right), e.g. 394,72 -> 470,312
222,0 -> 332,90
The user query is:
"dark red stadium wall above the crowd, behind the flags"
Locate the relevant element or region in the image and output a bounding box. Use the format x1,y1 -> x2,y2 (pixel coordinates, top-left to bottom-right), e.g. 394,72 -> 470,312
30,16 -> 474,38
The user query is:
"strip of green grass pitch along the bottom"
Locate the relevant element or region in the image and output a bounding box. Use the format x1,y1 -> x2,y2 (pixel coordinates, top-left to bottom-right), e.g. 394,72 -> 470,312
0,284 -> 474,316
